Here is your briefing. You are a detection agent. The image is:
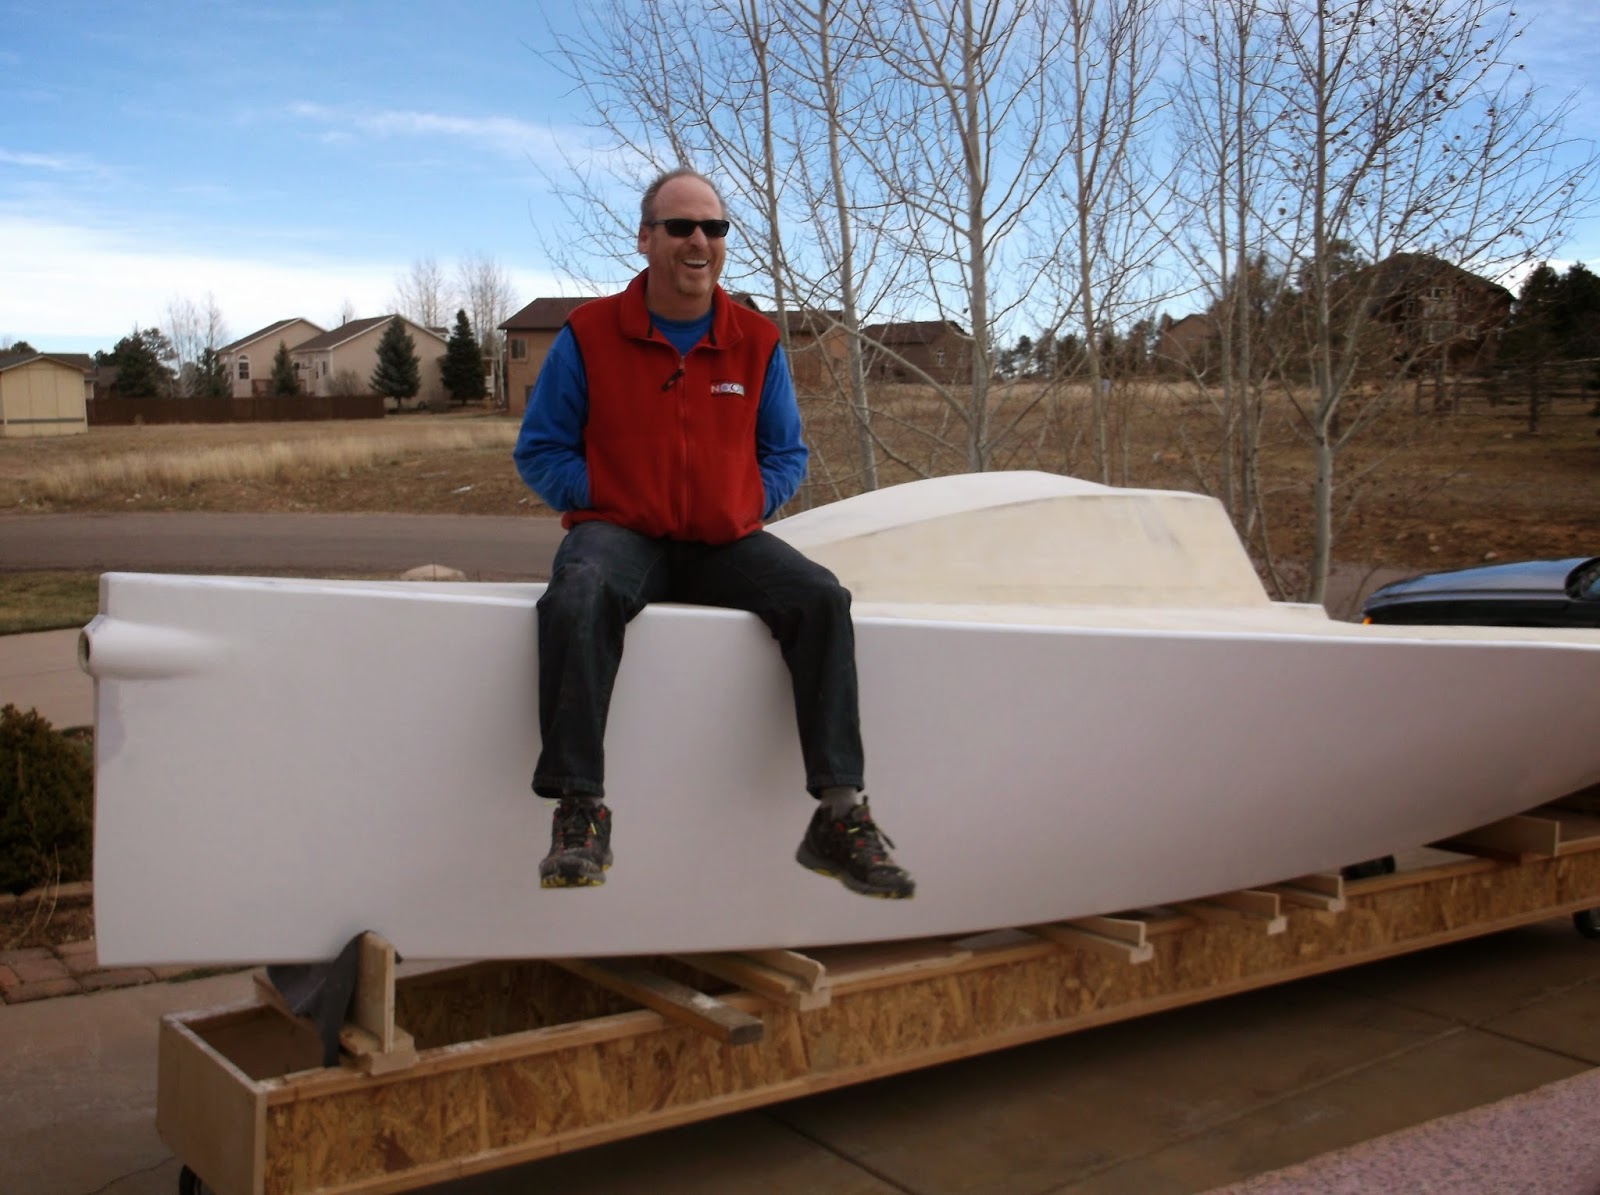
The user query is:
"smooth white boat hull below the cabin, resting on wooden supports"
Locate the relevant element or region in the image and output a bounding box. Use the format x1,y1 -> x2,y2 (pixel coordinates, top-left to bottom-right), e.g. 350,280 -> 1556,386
85,473 -> 1600,965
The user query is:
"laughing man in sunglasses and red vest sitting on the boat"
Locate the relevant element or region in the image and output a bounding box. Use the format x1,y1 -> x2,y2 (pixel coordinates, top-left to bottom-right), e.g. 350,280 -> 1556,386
514,170 -> 915,897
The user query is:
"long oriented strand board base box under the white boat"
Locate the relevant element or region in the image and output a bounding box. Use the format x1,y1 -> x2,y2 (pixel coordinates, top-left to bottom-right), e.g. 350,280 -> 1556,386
158,848 -> 1600,1195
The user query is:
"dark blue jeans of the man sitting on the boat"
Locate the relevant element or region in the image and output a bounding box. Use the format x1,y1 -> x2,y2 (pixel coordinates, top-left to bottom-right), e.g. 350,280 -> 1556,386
533,520 -> 864,797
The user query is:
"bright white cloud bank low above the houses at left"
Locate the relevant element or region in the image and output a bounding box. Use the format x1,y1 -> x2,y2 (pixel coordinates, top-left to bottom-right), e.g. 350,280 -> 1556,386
0,213 -> 563,352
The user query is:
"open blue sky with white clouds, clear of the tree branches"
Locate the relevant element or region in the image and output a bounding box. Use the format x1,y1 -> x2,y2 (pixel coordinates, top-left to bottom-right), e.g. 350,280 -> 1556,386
0,0 -> 1600,352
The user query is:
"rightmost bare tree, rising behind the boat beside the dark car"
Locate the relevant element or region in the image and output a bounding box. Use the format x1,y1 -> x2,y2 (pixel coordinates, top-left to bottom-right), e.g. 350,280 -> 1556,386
1267,0 -> 1595,601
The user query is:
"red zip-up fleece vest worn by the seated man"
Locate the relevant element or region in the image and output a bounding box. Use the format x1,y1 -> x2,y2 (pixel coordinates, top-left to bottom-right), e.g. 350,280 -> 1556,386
562,274 -> 778,544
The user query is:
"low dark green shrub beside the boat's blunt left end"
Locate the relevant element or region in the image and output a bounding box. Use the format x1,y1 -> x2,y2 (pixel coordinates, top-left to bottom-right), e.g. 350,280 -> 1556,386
0,705 -> 94,893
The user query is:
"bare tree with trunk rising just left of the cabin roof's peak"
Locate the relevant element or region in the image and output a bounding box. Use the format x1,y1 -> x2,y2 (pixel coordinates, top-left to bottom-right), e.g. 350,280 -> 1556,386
846,0 -> 1067,470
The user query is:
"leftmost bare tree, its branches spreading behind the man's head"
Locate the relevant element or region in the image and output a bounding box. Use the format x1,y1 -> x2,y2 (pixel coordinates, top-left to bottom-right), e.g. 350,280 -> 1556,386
547,0 -> 915,490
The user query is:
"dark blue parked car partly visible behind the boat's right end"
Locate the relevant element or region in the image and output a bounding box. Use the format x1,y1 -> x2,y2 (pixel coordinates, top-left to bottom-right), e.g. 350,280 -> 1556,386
1362,557 -> 1600,627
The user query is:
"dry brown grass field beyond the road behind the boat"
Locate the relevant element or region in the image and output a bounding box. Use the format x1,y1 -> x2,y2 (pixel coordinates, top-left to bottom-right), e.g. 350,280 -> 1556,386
0,386 -> 1600,588
